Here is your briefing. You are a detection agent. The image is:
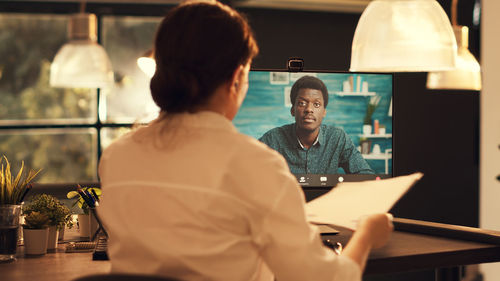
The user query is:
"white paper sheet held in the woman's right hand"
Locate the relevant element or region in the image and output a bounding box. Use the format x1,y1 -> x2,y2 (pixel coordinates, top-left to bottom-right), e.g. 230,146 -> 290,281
306,173 -> 423,230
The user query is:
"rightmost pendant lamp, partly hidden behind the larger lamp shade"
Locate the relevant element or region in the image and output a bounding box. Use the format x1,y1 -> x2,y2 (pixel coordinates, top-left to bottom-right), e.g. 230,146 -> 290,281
427,0 -> 482,91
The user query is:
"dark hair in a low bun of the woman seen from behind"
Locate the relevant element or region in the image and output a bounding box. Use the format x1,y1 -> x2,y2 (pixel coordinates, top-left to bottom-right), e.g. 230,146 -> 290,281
150,1 -> 258,113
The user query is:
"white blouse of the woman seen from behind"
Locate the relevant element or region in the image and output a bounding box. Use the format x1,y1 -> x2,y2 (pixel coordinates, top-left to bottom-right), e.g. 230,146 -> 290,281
98,112 -> 361,281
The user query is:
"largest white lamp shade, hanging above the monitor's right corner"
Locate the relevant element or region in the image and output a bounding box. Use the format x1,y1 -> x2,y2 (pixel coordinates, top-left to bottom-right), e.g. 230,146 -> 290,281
350,0 -> 457,72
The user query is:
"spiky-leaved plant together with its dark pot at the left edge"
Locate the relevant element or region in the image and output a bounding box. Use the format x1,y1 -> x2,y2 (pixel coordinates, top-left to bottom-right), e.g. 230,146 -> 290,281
0,155 -> 40,262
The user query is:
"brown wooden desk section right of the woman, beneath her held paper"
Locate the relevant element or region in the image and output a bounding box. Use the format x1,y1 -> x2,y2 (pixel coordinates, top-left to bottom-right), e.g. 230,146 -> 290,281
324,228 -> 500,281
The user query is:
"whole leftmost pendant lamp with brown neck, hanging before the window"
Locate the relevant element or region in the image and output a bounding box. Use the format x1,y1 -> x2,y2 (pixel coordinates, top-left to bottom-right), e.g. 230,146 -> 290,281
50,13 -> 114,88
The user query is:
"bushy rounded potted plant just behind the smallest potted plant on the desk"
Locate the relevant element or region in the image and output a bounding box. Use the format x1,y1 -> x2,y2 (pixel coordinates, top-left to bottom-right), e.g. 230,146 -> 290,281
23,194 -> 72,250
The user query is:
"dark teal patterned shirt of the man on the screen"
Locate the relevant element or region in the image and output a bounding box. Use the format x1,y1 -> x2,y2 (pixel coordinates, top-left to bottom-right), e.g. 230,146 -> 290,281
259,123 -> 374,174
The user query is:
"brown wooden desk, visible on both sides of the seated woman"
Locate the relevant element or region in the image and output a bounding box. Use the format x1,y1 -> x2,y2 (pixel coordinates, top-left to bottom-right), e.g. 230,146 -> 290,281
0,226 -> 500,281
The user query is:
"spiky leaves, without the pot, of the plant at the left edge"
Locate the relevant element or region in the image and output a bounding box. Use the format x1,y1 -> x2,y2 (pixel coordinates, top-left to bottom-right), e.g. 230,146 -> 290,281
0,155 -> 41,205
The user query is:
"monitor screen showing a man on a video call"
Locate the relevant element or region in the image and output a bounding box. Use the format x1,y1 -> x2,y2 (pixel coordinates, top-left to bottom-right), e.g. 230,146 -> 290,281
233,70 -> 393,186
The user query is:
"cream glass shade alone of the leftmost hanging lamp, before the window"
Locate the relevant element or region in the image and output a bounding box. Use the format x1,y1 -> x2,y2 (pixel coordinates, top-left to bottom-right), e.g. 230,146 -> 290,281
50,40 -> 114,88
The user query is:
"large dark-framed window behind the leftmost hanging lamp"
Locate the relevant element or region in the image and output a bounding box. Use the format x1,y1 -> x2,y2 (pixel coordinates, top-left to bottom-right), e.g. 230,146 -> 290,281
0,13 -> 161,183
